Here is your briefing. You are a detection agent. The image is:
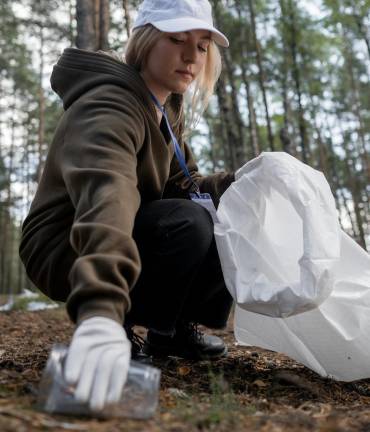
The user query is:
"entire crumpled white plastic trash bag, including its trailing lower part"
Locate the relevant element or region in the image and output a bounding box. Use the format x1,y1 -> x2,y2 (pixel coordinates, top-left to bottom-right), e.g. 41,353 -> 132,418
215,153 -> 370,381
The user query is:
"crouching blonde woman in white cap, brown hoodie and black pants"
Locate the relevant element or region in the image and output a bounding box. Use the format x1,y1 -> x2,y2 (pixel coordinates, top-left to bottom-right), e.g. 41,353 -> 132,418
20,0 -> 234,409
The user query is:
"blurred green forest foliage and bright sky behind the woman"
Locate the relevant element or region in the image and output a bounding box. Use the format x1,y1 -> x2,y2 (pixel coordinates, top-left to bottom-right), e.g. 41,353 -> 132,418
0,0 -> 370,291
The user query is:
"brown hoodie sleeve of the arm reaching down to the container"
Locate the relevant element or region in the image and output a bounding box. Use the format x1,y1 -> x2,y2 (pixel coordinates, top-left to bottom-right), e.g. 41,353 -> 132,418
60,90 -> 144,323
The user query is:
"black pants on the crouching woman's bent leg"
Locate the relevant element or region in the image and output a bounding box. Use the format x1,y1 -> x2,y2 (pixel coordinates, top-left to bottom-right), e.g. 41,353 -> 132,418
126,199 -> 232,333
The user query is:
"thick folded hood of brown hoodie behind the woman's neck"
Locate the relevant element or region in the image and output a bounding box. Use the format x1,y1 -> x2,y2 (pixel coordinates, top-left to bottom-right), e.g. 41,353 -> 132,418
50,48 -> 155,115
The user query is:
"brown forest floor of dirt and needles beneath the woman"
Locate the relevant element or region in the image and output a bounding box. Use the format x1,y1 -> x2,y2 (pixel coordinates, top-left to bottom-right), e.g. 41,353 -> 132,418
0,308 -> 370,432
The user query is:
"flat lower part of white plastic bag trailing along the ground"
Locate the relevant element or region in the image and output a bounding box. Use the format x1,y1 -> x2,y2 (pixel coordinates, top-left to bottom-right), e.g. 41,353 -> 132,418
234,233 -> 370,381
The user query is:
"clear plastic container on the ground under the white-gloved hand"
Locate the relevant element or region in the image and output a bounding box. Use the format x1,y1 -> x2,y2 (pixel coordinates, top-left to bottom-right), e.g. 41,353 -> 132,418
38,344 -> 161,419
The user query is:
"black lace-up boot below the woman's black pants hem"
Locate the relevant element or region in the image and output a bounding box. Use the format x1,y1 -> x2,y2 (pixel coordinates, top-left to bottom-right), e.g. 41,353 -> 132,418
143,323 -> 227,360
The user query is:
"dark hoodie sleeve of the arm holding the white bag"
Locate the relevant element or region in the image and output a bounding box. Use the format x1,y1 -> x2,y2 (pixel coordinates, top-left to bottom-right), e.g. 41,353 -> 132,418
165,143 -> 235,208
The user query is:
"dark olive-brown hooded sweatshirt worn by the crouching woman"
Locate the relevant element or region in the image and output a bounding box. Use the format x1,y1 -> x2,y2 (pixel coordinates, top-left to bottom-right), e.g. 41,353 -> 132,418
20,48 -> 234,323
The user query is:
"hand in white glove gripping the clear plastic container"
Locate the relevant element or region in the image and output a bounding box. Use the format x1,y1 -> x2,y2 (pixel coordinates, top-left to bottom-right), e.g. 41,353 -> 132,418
64,317 -> 131,411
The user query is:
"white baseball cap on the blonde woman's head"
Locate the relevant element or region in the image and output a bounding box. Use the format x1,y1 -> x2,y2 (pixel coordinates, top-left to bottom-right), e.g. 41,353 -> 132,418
133,0 -> 229,47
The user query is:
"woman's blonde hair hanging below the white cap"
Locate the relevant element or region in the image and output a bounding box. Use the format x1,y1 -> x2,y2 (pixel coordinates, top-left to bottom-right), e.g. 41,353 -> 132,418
125,24 -> 222,130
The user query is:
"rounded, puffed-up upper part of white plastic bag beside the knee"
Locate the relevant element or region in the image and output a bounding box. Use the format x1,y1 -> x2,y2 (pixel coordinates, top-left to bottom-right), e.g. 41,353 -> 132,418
215,153 -> 340,317
